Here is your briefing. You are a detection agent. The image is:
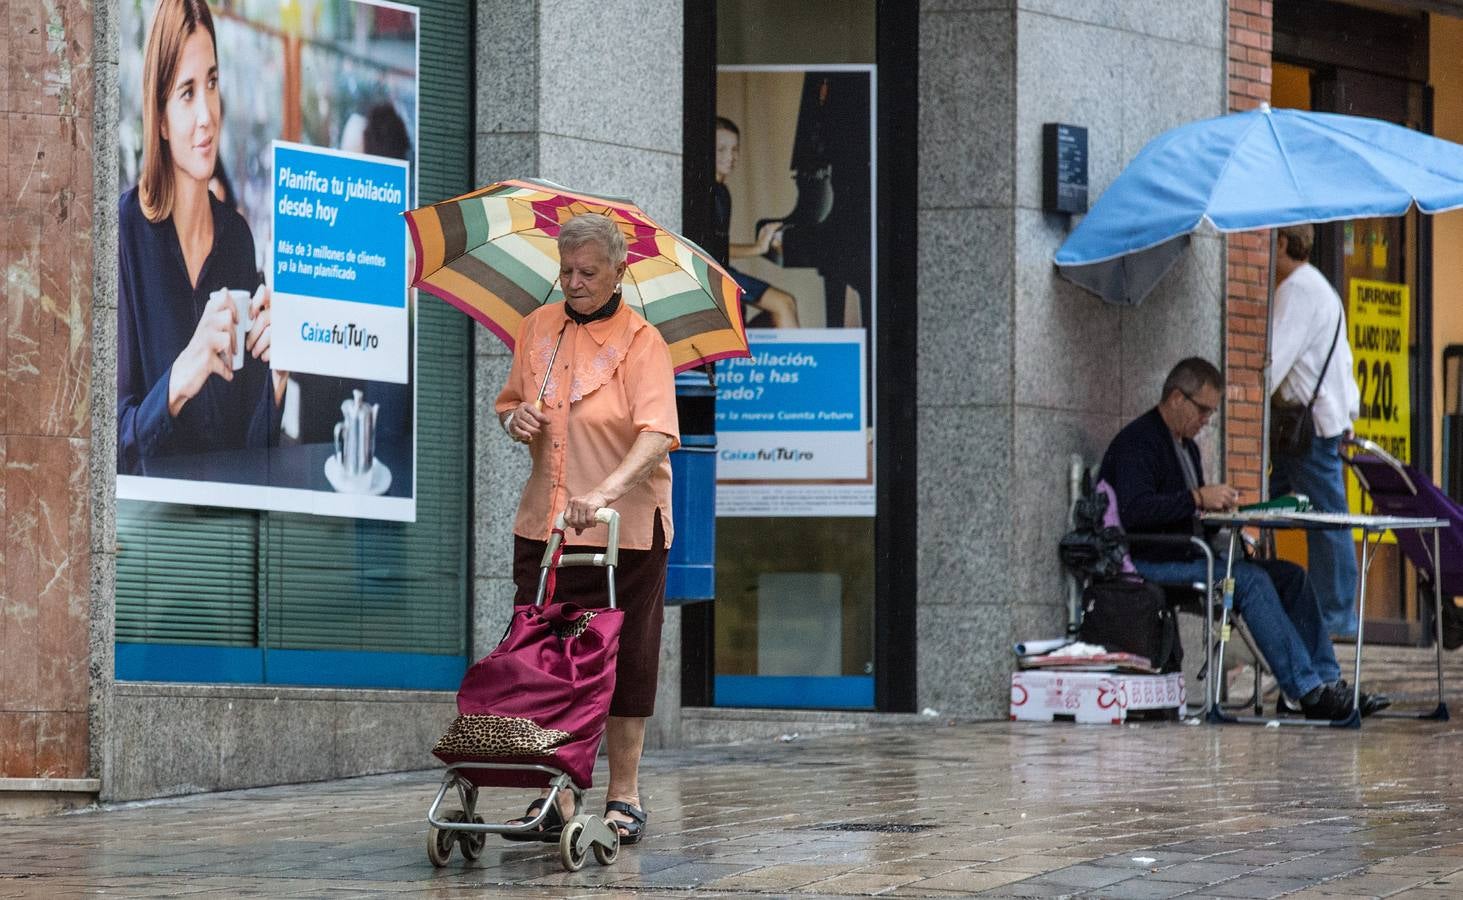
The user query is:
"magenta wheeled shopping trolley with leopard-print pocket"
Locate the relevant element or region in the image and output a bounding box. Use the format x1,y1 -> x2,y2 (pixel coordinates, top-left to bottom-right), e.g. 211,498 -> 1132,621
427,509 -> 625,872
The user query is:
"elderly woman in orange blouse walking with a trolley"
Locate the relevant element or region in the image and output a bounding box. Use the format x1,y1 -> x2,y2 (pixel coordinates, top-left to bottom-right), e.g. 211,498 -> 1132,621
496,214 -> 680,844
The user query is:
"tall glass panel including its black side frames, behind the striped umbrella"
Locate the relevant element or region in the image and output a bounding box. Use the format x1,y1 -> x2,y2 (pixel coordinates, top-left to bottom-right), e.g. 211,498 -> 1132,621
682,0 -> 919,711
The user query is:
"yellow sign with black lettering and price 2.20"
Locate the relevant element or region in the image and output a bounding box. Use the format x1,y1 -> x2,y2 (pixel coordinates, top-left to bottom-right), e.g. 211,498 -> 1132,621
1346,278 -> 1412,523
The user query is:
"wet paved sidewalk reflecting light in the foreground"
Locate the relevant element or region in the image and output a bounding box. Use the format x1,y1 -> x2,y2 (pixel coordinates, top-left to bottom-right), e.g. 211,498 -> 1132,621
0,720 -> 1463,900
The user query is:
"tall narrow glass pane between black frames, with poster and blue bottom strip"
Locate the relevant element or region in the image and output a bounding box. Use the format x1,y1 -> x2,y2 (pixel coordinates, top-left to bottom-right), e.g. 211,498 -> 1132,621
705,0 -> 884,708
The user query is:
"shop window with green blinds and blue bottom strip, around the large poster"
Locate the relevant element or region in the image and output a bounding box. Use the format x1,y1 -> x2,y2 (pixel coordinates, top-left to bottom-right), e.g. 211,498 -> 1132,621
116,0 -> 473,689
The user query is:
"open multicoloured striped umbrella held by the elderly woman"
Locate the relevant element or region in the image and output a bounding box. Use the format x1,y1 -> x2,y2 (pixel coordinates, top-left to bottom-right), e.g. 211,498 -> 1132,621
407,179 -> 749,372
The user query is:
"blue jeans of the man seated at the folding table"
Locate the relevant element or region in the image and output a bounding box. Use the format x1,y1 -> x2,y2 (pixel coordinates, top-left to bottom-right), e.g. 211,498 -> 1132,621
1132,556 -> 1342,700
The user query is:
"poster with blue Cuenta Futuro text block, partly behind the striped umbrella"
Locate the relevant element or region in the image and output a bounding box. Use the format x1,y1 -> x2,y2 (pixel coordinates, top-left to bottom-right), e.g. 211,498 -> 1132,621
710,66 -> 876,518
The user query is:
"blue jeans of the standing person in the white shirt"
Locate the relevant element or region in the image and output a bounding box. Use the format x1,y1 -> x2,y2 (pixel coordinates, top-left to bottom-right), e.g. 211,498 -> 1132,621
1270,436 -> 1356,638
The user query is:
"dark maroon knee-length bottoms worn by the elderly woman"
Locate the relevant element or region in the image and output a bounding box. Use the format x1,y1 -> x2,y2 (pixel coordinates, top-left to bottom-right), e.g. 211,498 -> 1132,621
514,509 -> 667,717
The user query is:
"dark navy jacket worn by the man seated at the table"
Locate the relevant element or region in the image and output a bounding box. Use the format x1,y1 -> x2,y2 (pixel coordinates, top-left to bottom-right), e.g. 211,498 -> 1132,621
1099,407 -> 1204,559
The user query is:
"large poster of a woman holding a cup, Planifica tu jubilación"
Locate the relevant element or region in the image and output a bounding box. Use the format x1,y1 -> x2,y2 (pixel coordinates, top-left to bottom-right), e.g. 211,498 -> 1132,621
117,0 -> 418,521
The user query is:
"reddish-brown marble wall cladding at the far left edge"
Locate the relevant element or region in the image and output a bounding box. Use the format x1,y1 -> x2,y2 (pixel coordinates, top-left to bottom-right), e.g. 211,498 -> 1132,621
0,0 -> 94,779
